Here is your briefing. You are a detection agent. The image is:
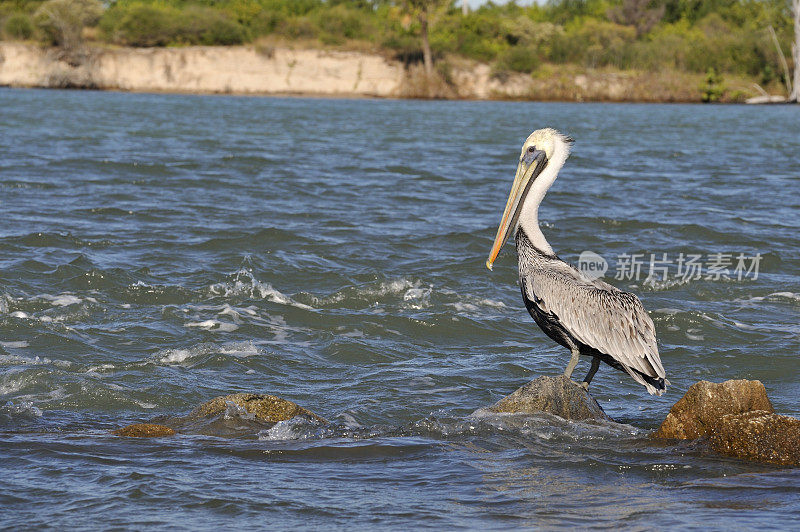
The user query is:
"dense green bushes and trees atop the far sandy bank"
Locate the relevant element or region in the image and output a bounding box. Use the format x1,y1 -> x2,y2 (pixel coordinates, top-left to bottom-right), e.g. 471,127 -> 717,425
0,0 -> 792,83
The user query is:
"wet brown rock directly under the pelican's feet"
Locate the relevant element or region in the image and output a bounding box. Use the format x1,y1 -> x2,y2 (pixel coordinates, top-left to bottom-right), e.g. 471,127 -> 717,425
488,375 -> 611,421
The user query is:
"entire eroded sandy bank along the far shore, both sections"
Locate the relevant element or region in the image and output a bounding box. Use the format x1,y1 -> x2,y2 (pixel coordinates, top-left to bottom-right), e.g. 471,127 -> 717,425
0,42 -> 712,101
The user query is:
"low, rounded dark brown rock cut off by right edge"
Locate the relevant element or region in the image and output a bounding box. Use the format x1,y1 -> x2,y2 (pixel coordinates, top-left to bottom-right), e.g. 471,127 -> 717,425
708,410 -> 800,466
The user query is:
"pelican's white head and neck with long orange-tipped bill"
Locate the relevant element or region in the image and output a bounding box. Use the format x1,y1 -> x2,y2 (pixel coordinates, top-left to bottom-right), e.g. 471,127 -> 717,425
486,128 -> 574,270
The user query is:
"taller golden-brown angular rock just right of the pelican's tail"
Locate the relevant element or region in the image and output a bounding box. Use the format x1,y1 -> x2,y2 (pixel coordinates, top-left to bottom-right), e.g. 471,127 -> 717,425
653,380 -> 775,440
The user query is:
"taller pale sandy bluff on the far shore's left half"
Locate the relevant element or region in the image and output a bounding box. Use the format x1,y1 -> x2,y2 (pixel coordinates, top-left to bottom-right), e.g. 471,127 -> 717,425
0,43 -> 403,97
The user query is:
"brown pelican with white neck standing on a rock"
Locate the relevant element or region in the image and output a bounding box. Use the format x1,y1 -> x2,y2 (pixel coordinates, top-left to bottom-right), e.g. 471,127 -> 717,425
486,128 -> 669,395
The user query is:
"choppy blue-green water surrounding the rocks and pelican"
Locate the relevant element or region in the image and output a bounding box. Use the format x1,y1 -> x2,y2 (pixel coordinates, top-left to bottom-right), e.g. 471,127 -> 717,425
0,90 -> 800,529
